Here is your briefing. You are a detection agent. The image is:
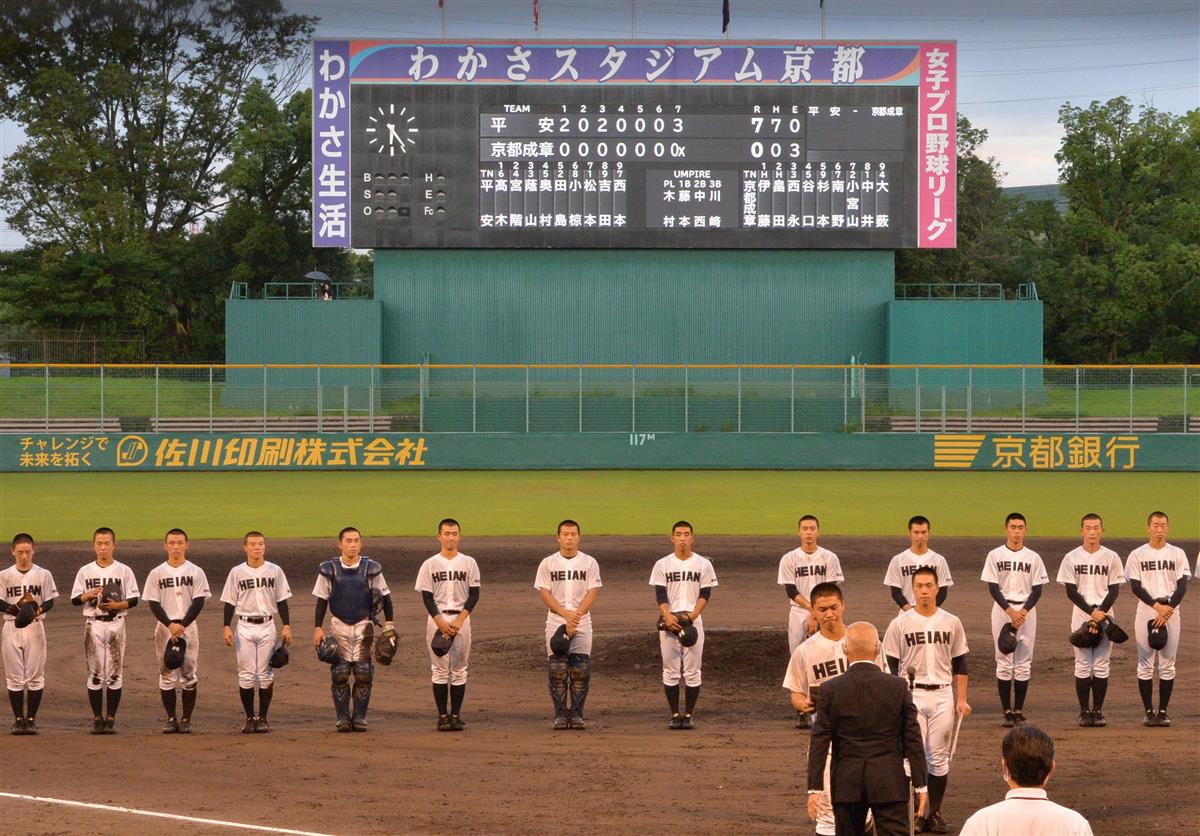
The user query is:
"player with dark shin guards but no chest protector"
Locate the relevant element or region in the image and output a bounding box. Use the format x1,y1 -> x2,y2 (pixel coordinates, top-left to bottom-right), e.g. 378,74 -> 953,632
533,519 -> 604,730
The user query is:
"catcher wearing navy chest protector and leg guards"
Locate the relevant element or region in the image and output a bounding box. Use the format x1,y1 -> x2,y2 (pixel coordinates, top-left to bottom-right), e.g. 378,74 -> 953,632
312,528 -> 394,732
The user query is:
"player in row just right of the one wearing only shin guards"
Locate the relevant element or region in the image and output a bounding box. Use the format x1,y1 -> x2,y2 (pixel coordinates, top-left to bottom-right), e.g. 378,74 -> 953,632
650,519 -> 718,729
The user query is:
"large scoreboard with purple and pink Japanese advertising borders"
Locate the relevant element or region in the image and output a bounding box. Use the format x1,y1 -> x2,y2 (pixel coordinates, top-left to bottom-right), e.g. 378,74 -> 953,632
312,40 -> 955,249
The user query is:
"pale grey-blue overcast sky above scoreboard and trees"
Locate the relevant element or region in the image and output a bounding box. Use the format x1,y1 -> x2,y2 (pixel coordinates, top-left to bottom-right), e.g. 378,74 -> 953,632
0,0 -> 1200,246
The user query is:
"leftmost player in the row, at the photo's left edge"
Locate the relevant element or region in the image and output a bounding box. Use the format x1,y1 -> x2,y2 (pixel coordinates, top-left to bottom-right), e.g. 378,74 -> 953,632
0,534 -> 59,734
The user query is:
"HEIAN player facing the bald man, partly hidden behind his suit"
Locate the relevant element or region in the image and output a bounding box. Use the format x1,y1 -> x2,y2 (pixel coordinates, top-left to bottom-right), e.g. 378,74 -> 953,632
784,581 -> 887,836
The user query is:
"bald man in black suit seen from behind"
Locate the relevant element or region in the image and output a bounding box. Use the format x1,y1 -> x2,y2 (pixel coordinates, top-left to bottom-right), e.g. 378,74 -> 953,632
808,621 -> 926,836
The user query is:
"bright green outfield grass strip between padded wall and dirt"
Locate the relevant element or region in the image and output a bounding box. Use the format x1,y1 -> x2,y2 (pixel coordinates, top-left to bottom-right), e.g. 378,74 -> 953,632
0,470 -> 1200,541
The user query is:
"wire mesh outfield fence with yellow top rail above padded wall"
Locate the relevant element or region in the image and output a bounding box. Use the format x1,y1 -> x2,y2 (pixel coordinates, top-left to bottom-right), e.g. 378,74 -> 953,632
0,363 -> 1200,433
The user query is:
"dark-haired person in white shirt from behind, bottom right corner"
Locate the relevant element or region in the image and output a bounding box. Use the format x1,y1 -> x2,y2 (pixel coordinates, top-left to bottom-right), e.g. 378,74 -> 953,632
959,723 -> 1092,836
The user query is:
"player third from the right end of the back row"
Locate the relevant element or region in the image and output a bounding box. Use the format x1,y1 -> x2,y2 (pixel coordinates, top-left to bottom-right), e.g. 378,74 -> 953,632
979,513 -> 1050,728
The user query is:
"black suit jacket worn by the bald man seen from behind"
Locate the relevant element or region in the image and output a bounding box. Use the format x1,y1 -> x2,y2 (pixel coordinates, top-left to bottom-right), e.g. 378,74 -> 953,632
809,662 -> 925,804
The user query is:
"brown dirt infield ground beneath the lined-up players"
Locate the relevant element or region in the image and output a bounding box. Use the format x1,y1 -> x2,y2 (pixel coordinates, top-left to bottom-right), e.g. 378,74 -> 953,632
0,536 -> 1200,834
